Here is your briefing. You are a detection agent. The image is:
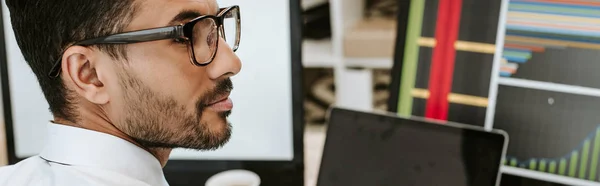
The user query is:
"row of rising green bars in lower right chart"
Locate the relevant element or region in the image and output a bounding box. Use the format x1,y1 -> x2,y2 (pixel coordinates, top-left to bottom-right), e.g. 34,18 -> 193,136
504,127 -> 600,181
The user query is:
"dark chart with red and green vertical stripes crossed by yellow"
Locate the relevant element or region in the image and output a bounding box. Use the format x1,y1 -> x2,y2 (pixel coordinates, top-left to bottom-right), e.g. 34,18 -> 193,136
392,0 -> 502,126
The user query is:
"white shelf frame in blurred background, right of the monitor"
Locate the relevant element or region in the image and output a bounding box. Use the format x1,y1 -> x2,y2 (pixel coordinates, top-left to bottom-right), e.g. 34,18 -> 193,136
302,0 -> 394,110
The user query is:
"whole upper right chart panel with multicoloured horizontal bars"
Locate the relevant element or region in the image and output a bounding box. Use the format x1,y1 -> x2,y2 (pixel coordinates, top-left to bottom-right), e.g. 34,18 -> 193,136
500,0 -> 600,81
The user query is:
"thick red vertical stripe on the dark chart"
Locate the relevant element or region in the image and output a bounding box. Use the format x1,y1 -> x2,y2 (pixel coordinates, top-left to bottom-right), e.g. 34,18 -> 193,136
425,0 -> 462,120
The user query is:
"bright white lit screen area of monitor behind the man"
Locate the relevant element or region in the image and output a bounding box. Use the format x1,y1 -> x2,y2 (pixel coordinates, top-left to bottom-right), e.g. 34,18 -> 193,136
2,0 -> 294,163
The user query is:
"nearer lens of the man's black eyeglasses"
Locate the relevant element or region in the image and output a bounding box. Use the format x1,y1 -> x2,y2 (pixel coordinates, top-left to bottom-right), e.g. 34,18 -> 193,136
193,19 -> 219,64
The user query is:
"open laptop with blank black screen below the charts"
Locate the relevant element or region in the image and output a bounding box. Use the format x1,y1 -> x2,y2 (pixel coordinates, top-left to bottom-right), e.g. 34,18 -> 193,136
317,107 -> 508,186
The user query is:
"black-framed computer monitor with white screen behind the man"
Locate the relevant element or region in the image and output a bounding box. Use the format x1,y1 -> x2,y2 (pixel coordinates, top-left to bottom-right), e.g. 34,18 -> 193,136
0,0 -> 304,186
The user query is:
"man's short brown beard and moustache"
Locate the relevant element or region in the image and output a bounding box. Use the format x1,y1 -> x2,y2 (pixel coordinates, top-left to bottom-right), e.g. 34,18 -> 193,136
121,70 -> 233,150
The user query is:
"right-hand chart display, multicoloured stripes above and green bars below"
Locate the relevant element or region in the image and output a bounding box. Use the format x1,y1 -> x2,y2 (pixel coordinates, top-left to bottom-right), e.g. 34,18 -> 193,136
493,0 -> 600,186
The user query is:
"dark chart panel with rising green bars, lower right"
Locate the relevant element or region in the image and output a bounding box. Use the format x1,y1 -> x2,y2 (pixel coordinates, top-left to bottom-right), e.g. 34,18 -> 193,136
494,86 -> 600,181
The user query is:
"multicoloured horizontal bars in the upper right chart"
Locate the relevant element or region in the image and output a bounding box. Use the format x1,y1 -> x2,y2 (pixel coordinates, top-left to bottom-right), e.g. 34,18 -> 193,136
500,0 -> 600,77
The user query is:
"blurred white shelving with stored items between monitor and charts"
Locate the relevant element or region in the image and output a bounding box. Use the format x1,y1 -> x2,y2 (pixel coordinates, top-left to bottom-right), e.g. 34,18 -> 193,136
302,0 -> 397,182
